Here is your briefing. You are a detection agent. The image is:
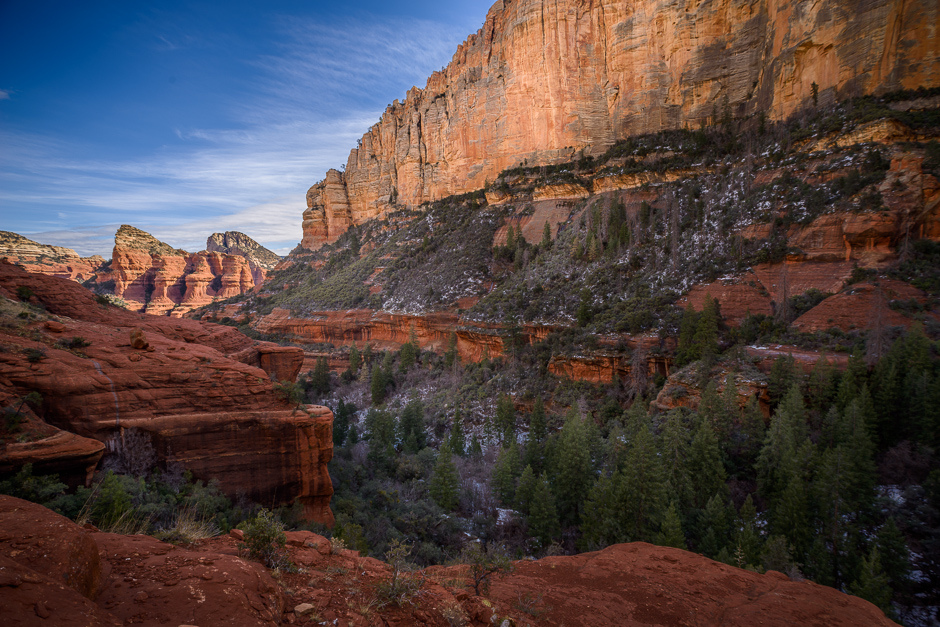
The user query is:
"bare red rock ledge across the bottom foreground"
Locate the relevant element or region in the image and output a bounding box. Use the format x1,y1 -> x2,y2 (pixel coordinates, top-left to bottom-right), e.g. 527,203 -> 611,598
0,496 -> 894,627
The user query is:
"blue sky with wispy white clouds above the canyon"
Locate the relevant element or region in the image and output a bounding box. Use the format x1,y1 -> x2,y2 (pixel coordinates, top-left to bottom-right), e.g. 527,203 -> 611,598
0,0 -> 492,258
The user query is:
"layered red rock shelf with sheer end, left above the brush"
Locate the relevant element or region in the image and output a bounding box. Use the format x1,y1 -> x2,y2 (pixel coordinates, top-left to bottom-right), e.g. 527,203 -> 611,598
0,263 -> 333,524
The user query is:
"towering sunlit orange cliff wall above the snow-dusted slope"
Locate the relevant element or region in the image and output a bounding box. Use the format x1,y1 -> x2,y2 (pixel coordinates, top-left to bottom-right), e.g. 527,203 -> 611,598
303,0 -> 940,248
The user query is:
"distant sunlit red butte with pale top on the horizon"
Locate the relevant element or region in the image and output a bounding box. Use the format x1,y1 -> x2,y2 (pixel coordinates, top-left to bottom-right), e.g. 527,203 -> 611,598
110,225 -> 264,317
